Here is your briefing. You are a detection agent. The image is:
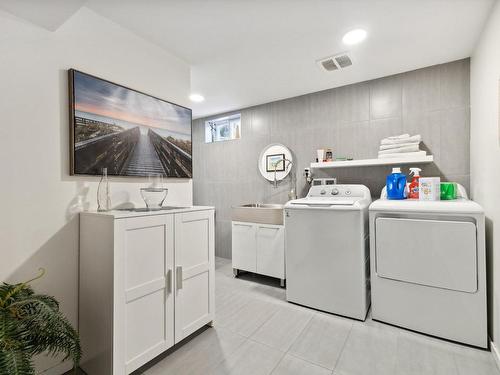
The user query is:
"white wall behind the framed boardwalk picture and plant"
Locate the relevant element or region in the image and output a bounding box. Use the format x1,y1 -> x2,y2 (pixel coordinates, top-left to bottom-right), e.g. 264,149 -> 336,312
0,8 -> 192,373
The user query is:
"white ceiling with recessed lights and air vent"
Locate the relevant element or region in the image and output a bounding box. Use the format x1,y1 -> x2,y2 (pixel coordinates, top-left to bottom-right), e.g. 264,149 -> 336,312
0,0 -> 495,117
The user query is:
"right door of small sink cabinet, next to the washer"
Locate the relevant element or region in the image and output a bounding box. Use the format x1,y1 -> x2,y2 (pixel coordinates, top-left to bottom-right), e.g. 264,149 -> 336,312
257,225 -> 285,279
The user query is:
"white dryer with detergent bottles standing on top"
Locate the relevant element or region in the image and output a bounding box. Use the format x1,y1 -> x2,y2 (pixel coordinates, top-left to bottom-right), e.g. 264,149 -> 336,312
370,186 -> 488,348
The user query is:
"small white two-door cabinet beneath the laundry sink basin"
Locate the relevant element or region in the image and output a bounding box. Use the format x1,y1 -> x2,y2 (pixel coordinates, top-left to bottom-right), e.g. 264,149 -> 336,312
232,221 -> 285,281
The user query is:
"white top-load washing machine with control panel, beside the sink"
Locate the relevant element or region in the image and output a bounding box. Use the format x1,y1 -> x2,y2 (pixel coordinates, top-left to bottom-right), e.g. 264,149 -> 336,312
285,184 -> 371,320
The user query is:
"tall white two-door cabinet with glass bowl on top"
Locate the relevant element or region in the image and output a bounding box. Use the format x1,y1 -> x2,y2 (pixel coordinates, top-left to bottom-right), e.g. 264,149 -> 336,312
79,207 -> 215,375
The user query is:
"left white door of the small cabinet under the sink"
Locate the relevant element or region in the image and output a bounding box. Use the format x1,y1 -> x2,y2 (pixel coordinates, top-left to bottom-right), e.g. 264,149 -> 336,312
232,221 -> 257,272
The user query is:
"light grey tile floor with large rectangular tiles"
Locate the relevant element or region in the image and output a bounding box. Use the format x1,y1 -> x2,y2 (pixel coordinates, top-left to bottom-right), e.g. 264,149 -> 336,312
140,258 -> 500,375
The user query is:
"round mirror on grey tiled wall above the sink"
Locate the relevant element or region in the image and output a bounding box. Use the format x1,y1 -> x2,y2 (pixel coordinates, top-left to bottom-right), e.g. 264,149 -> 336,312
259,143 -> 293,181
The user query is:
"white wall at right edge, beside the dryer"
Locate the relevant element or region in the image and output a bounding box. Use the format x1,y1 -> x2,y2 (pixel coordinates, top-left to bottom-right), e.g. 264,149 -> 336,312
470,1 -> 500,352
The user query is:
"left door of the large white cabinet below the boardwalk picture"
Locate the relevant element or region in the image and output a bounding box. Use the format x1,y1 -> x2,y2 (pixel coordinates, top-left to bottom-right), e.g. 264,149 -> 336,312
114,215 -> 174,374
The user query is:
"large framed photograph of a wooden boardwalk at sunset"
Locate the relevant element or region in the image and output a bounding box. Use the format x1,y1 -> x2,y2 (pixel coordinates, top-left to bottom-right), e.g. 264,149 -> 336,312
68,69 -> 192,178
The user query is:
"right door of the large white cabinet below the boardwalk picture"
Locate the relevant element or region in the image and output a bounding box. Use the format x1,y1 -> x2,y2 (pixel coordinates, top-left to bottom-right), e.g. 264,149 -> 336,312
175,210 -> 215,343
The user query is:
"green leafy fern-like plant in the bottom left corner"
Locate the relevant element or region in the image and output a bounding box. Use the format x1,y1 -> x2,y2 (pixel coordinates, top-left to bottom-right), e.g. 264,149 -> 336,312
0,269 -> 81,375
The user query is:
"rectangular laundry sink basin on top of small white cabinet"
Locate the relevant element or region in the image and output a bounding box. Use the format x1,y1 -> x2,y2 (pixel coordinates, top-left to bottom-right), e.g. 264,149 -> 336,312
231,203 -> 283,225
